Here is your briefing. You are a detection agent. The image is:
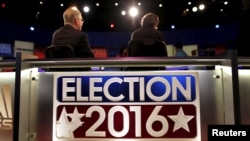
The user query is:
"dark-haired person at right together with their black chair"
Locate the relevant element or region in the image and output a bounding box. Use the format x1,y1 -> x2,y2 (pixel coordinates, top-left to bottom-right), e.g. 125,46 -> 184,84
128,12 -> 167,70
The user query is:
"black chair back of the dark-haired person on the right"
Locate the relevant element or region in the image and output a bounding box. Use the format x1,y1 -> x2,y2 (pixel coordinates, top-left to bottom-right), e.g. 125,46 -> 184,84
127,39 -> 168,70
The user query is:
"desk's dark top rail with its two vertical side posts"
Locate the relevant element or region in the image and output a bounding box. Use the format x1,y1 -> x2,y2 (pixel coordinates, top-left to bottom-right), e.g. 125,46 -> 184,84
0,50 -> 250,140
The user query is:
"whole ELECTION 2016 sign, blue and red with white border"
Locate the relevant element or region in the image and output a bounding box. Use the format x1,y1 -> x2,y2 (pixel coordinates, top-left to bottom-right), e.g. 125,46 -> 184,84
53,71 -> 201,141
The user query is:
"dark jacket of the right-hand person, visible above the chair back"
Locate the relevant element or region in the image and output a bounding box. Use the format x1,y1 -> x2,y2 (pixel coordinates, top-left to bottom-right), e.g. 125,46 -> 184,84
131,27 -> 165,42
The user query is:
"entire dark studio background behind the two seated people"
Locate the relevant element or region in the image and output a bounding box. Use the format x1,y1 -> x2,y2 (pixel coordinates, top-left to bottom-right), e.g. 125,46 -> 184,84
0,0 -> 242,56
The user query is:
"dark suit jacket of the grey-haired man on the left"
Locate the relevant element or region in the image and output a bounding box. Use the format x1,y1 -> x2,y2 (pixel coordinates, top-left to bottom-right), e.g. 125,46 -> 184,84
52,24 -> 94,58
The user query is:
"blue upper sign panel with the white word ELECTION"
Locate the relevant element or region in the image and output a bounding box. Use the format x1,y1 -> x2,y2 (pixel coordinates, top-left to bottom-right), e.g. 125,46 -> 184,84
57,75 -> 196,102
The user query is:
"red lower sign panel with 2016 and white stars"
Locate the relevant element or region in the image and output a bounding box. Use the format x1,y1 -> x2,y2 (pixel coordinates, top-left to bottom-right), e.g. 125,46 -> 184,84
55,104 -> 197,139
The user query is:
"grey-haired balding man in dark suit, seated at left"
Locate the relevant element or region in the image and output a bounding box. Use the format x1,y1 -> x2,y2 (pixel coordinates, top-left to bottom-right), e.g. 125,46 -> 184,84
52,7 -> 94,58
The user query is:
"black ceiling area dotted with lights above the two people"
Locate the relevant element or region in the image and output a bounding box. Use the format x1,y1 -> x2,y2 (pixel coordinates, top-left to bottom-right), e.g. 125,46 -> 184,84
0,0 -> 241,31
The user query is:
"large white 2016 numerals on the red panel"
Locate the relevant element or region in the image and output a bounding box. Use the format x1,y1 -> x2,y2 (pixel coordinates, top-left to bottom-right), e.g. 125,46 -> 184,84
85,106 -> 169,137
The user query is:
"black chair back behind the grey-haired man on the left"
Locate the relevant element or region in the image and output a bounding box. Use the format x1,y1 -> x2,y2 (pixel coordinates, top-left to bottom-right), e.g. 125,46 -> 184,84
45,45 -> 75,58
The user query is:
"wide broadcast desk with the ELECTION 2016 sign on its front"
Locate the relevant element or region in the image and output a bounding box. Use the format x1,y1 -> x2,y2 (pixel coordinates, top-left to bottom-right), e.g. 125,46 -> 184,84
0,50 -> 250,141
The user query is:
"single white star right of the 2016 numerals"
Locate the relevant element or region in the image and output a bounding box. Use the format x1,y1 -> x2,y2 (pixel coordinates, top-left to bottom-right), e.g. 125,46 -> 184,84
168,107 -> 194,132
